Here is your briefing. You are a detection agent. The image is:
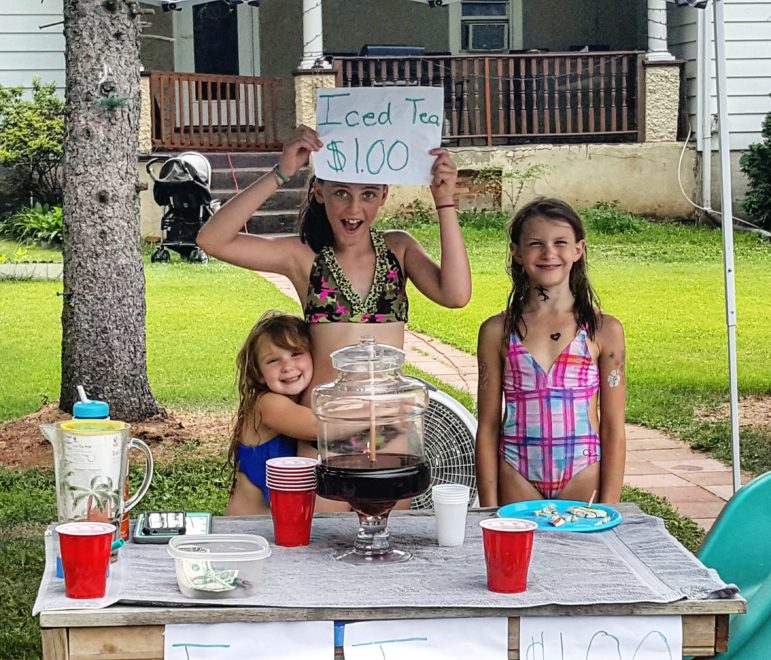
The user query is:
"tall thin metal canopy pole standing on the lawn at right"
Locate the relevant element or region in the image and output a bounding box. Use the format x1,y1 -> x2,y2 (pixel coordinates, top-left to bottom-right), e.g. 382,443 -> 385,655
714,0 -> 742,493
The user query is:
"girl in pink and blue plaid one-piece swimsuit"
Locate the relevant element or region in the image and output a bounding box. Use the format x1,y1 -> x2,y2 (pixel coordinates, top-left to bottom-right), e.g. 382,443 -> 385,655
476,198 -> 626,506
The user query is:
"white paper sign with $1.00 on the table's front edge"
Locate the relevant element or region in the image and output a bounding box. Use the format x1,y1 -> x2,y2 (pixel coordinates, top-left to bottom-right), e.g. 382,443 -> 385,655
519,616 -> 683,660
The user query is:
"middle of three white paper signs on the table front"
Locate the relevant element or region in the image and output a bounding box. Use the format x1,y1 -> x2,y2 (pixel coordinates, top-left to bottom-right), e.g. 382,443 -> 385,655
344,617 -> 509,660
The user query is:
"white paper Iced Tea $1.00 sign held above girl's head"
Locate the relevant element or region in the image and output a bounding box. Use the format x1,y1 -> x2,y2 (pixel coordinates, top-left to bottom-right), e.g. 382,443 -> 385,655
313,87 -> 444,184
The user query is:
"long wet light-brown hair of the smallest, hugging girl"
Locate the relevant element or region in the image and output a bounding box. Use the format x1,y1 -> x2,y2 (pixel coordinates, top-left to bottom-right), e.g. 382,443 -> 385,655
227,310 -> 311,493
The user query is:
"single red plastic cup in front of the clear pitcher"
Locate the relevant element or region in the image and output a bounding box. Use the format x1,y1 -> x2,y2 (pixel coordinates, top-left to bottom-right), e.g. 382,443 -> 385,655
56,522 -> 115,598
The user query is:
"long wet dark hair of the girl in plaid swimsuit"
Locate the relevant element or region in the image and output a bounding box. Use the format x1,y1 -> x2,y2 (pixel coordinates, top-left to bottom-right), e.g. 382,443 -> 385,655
504,197 -> 600,341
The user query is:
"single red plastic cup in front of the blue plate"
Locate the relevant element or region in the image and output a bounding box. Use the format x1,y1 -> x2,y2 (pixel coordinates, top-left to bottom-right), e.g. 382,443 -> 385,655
479,518 -> 538,594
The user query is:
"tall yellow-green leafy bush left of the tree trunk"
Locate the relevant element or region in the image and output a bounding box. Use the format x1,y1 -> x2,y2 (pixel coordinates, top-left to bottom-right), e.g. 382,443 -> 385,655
0,78 -> 64,204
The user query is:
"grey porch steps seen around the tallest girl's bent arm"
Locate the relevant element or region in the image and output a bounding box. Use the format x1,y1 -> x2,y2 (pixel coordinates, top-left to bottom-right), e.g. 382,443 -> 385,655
204,152 -> 310,234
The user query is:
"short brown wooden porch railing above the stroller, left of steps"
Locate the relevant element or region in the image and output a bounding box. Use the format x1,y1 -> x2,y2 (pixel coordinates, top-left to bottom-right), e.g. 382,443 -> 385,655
150,72 -> 282,151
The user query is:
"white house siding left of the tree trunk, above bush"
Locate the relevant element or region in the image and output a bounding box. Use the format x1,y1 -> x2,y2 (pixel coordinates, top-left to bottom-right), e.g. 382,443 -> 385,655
0,0 -> 64,96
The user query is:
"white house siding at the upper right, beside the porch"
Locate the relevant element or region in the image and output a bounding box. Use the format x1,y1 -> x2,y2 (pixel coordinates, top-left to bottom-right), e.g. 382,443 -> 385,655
668,0 -> 771,151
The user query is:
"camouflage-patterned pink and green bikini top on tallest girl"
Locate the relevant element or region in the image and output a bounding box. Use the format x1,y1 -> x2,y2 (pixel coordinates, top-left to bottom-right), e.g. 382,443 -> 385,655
305,230 -> 409,323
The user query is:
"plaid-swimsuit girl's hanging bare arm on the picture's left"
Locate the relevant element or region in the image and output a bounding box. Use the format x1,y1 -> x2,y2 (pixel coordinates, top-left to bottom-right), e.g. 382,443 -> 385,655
475,314 -> 504,506
